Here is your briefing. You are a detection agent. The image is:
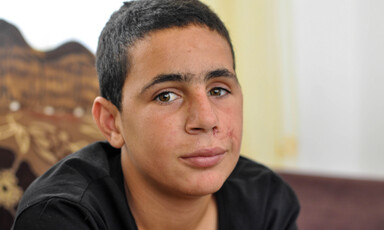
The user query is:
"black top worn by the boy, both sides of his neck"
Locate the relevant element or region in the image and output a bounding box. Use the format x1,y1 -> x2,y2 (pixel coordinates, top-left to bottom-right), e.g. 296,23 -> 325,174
13,142 -> 299,230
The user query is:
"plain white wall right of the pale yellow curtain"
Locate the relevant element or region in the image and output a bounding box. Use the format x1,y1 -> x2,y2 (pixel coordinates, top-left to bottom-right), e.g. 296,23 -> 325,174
293,0 -> 384,178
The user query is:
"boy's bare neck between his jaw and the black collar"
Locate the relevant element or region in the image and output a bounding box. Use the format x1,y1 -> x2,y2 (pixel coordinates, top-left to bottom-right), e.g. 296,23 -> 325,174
123,156 -> 218,230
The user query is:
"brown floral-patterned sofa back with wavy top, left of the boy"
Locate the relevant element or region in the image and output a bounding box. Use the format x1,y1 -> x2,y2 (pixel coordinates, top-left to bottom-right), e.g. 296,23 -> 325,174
0,19 -> 103,229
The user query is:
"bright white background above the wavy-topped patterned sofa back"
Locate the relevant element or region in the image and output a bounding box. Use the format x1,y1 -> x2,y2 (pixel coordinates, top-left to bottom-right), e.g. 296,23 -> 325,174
0,0 -> 124,52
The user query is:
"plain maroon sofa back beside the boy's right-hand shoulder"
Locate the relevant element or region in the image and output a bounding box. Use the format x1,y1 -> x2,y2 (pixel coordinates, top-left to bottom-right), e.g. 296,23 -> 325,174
280,172 -> 384,230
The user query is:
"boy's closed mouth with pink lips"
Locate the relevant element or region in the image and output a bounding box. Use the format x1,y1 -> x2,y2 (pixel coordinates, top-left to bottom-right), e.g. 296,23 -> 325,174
180,147 -> 226,168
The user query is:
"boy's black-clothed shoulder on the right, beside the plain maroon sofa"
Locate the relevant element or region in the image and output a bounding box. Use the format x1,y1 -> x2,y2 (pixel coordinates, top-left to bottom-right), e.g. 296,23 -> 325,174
218,157 -> 300,230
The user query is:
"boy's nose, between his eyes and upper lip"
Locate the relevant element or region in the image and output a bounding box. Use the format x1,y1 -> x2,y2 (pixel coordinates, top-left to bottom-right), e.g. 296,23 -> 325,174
185,93 -> 219,134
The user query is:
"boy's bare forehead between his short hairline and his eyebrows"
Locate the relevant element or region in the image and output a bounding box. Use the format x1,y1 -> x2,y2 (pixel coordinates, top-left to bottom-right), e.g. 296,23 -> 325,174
126,25 -> 236,91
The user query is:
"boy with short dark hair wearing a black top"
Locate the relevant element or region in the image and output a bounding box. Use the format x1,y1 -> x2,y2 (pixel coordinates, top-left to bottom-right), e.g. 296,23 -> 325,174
14,0 -> 299,230
